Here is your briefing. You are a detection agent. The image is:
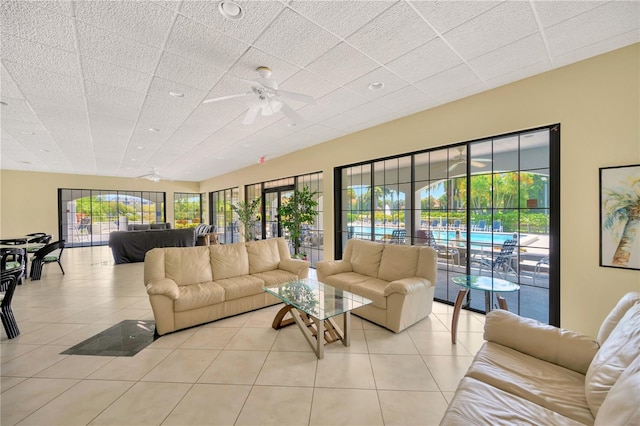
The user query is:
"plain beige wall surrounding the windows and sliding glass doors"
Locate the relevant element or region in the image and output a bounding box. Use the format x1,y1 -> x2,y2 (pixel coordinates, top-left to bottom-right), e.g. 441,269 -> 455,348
0,44 -> 640,335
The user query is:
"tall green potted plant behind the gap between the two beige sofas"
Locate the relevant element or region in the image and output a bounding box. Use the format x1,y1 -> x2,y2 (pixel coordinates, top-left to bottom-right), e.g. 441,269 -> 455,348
278,186 -> 318,257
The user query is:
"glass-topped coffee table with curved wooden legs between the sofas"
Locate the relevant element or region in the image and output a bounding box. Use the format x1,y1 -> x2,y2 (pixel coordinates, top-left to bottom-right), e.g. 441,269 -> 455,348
264,278 -> 371,359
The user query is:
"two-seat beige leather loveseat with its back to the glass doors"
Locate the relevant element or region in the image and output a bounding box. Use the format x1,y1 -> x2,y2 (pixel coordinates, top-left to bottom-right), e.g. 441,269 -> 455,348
316,239 -> 437,333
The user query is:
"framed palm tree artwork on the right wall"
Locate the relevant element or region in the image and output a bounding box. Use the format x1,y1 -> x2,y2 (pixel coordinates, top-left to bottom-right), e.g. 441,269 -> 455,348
600,164 -> 640,270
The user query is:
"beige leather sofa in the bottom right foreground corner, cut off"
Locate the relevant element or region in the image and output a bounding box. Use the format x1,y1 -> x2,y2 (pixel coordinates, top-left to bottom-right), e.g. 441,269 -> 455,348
440,292 -> 640,426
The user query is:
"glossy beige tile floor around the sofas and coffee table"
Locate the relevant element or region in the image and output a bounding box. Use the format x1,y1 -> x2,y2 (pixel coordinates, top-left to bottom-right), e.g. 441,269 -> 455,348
0,247 -> 484,426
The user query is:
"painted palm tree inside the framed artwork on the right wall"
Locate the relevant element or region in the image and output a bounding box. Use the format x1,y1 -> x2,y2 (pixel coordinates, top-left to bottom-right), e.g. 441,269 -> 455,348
603,176 -> 640,266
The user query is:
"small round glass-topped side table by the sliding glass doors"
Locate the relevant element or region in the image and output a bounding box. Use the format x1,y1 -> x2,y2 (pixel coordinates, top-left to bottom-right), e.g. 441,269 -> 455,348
451,275 -> 520,344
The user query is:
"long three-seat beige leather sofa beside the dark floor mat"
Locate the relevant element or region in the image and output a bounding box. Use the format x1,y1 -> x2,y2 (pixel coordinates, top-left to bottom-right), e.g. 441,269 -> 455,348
144,238 -> 309,335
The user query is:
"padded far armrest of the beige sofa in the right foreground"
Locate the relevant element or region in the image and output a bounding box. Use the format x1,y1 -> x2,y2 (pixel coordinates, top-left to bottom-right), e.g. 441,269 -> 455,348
484,309 -> 600,374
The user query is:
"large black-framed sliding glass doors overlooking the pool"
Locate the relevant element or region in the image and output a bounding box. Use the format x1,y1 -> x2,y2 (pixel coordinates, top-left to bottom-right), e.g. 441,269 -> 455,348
335,125 -> 560,325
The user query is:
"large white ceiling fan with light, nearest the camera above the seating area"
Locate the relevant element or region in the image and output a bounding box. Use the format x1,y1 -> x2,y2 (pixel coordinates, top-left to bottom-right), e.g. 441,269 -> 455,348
202,67 -> 316,125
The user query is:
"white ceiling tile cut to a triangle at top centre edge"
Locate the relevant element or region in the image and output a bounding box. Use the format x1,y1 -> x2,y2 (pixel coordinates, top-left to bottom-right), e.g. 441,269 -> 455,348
289,0 -> 395,38
